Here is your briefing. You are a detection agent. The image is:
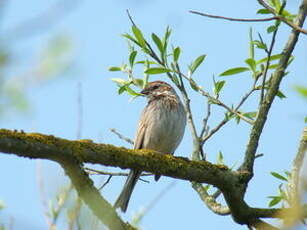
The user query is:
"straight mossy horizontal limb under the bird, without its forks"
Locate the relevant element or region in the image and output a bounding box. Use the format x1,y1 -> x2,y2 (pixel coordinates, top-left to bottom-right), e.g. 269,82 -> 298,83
0,129 -> 238,189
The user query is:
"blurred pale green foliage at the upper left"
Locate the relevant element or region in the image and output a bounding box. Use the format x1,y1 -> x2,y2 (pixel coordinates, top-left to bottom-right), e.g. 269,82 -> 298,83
0,35 -> 74,116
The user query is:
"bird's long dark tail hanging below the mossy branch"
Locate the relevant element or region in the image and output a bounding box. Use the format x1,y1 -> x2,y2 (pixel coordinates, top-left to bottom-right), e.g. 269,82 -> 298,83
114,170 -> 141,212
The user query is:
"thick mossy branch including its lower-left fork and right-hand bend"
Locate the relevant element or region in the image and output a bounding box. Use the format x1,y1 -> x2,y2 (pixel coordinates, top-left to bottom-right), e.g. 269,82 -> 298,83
0,129 -> 306,229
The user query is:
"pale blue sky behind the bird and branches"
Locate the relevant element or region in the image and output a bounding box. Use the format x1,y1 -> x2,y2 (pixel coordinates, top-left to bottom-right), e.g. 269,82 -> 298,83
0,0 -> 307,230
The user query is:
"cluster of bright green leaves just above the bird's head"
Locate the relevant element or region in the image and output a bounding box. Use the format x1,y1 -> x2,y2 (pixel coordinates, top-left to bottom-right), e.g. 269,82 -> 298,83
109,26 -> 208,96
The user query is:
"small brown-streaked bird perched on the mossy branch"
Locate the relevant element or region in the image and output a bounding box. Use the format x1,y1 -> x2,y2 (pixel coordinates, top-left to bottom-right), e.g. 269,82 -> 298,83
114,81 -> 186,212
